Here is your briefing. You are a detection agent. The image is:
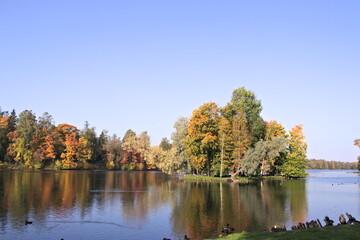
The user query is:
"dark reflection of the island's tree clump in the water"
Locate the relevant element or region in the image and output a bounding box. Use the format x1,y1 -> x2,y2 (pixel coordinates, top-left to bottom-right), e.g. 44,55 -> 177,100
172,180 -> 307,239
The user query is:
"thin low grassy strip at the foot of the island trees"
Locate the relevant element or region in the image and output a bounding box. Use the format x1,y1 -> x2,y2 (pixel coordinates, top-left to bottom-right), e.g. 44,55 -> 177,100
182,175 -> 285,183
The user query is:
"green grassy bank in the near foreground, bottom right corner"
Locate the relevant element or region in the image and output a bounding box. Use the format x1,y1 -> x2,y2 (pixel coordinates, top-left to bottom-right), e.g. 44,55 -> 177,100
205,224 -> 360,240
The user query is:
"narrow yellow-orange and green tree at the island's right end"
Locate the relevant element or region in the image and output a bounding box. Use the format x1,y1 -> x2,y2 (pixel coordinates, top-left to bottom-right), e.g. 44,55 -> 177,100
281,125 -> 307,178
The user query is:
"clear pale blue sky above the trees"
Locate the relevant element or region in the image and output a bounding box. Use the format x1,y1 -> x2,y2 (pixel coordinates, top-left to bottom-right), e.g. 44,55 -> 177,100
0,0 -> 360,161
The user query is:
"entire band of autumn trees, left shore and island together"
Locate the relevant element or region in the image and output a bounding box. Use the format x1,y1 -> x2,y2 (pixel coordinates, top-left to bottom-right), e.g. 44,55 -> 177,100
0,88 -> 307,177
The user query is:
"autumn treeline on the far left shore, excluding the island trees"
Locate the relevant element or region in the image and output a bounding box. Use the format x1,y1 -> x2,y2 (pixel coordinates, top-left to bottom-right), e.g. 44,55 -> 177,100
0,110 -> 155,170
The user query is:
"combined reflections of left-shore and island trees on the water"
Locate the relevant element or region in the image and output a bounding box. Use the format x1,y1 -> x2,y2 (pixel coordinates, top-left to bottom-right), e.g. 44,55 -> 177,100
0,171 -> 307,239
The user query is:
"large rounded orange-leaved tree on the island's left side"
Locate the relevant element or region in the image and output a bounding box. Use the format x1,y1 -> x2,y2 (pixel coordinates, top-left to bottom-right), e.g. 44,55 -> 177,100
185,102 -> 219,174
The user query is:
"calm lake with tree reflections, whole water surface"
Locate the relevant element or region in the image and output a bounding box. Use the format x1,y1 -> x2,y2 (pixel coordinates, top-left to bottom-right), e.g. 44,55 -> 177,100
0,170 -> 360,240
